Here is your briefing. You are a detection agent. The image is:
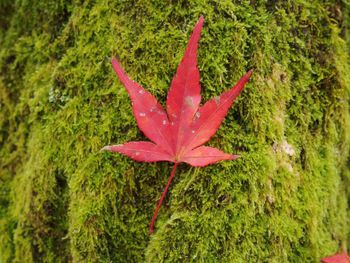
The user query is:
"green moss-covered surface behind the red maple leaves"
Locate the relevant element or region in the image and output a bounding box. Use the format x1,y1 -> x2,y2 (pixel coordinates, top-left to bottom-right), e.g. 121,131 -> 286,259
0,0 -> 350,262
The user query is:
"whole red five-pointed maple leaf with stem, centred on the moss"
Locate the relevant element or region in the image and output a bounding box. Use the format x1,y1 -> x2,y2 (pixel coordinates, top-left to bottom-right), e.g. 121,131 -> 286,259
102,17 -> 252,234
